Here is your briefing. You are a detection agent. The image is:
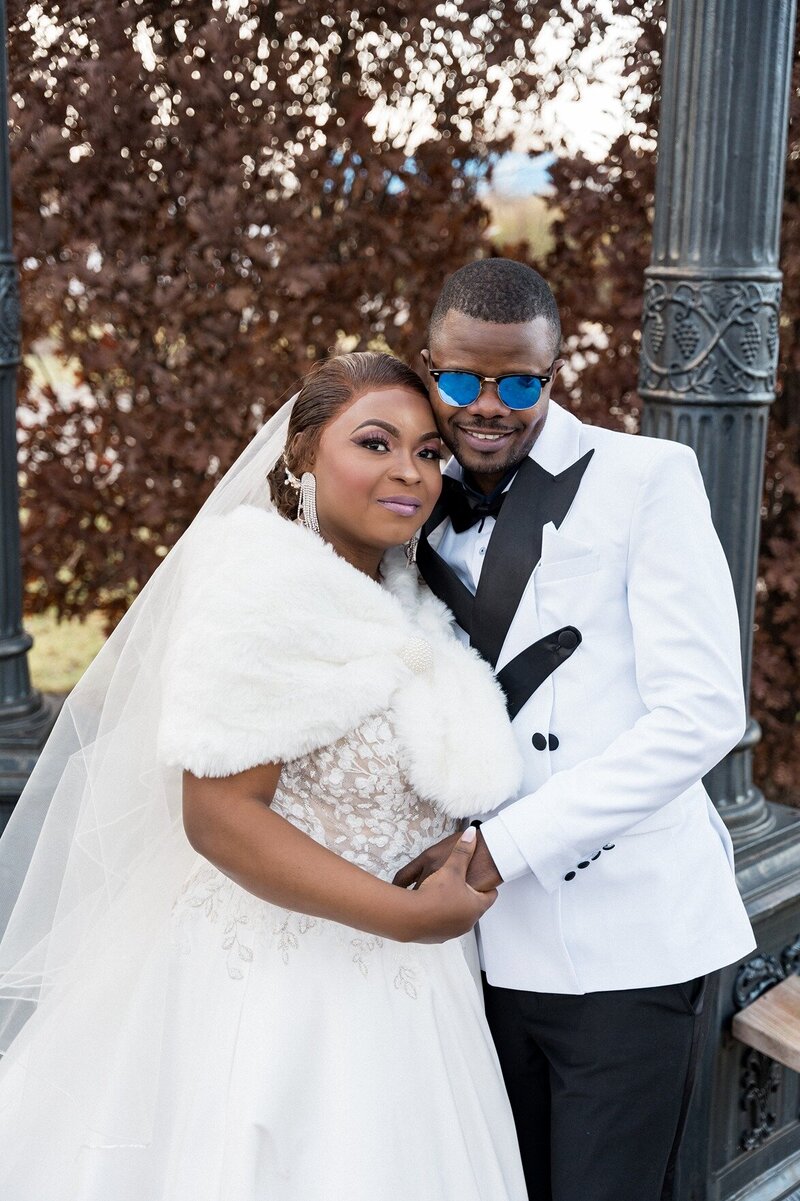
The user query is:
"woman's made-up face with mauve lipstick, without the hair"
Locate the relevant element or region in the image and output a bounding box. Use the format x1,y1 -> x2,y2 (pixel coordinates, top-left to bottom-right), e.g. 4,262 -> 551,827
310,387 -> 442,551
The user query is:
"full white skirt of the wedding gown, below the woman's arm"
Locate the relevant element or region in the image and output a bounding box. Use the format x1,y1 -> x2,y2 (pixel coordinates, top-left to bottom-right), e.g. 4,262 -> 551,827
0,865 -> 526,1201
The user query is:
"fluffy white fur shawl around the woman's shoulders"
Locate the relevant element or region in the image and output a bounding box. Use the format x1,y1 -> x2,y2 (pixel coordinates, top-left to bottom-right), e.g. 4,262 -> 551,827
159,506 -> 521,817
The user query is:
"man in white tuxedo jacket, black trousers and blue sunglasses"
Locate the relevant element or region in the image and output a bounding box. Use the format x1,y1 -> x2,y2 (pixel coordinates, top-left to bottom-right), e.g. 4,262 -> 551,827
396,259 -> 754,1201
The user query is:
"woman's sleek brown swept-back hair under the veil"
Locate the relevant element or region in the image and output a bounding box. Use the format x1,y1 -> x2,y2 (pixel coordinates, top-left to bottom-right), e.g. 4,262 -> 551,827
267,351 -> 428,520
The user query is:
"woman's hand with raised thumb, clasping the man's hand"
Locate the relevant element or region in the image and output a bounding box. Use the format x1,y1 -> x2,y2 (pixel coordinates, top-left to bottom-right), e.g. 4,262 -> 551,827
396,826 -> 497,943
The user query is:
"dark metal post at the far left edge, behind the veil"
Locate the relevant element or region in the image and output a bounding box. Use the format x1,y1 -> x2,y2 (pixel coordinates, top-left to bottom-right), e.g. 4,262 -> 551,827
0,0 -> 58,830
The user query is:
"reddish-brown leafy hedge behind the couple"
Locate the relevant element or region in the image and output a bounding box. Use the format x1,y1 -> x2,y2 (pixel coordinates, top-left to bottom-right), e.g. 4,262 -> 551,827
8,0 -> 800,799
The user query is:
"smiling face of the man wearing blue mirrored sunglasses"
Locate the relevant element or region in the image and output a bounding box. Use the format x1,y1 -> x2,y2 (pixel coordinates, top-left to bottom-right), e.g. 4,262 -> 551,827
422,309 -> 561,491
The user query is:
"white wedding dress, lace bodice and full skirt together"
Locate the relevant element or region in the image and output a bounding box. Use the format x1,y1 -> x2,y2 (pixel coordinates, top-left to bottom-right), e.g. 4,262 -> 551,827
0,715 -> 526,1201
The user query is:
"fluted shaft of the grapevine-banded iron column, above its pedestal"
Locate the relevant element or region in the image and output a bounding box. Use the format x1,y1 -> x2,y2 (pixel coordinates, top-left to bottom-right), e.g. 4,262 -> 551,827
639,0 -> 795,844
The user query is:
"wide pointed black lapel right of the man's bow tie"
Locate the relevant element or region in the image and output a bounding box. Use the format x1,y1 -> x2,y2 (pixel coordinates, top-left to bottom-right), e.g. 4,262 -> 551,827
471,449 -> 595,667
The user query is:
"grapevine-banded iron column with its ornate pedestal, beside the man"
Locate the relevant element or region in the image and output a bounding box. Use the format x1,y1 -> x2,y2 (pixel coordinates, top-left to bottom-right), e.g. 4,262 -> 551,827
640,0 -> 800,1201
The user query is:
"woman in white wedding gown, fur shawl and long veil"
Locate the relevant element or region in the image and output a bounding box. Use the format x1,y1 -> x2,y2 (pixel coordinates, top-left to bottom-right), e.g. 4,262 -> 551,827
0,353 -> 526,1201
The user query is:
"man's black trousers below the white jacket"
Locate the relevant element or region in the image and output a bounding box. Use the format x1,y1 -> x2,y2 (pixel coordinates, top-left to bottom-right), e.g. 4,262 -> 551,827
484,978 -> 705,1201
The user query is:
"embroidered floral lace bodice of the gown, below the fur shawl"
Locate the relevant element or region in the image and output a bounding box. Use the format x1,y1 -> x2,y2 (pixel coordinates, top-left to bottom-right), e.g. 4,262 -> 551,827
267,713 -> 456,880
